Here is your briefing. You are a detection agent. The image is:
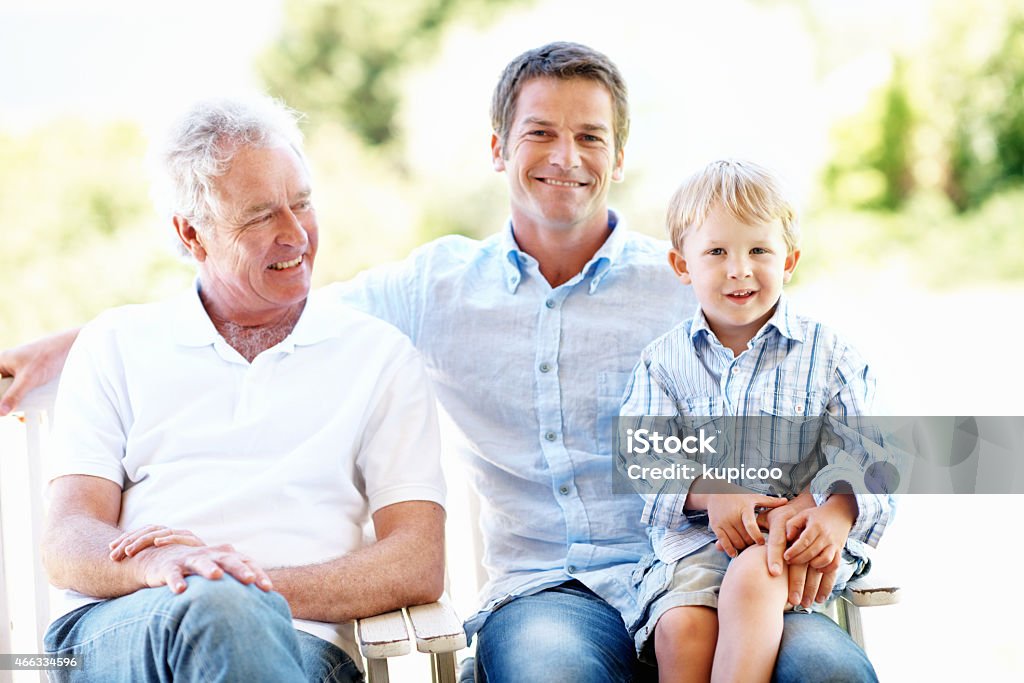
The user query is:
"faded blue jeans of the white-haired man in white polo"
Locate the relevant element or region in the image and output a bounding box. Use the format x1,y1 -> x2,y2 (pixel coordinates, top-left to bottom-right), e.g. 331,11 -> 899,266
44,577 -> 362,683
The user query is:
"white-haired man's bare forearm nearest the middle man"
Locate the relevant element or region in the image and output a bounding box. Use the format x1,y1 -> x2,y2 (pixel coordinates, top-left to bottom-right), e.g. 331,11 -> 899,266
267,502 -> 444,623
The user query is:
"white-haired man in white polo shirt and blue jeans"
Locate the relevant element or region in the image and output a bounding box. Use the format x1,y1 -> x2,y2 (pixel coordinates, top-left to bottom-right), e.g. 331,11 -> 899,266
35,100 -> 444,683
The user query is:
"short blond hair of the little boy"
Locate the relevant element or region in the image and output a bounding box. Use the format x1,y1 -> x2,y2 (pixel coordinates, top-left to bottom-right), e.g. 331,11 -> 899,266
666,159 -> 800,254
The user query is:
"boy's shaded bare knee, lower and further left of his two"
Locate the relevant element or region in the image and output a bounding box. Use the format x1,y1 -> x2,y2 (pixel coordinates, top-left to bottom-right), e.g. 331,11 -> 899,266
654,605 -> 718,683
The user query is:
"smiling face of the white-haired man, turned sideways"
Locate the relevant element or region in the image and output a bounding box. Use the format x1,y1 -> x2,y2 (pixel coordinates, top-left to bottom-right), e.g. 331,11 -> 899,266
193,144 -> 317,325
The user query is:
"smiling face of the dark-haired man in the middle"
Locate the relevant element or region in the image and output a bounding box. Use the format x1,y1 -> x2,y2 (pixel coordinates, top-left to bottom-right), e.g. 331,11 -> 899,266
490,78 -> 623,237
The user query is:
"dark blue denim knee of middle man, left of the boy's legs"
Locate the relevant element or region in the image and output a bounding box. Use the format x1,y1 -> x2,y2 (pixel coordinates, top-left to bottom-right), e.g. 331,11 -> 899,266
475,582 -> 636,683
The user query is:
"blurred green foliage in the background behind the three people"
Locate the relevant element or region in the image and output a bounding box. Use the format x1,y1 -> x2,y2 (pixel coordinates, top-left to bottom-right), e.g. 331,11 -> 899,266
0,0 -> 1024,346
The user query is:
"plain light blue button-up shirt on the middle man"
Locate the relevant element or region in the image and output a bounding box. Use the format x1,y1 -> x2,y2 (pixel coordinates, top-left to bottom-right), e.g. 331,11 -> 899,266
331,212 -> 696,636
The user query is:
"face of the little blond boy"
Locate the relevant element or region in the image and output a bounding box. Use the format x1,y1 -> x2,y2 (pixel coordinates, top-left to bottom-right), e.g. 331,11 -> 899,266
669,207 -> 800,350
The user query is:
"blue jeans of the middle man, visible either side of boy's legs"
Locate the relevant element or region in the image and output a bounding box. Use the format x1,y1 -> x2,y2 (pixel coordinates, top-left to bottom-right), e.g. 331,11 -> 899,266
461,581 -> 878,683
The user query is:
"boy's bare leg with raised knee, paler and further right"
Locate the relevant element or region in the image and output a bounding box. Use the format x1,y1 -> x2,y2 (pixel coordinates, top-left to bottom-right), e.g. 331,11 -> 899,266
712,546 -> 790,683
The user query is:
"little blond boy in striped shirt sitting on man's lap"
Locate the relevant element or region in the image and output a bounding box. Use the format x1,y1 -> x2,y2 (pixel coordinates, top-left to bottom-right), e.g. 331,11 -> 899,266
621,161 -> 891,682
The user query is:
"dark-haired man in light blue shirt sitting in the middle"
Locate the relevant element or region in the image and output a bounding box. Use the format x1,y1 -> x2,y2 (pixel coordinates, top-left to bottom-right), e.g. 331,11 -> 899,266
0,43 -> 873,682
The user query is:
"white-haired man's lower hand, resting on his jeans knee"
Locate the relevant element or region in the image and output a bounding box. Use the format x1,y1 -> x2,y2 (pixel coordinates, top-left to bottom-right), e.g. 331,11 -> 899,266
126,543 -> 273,593
